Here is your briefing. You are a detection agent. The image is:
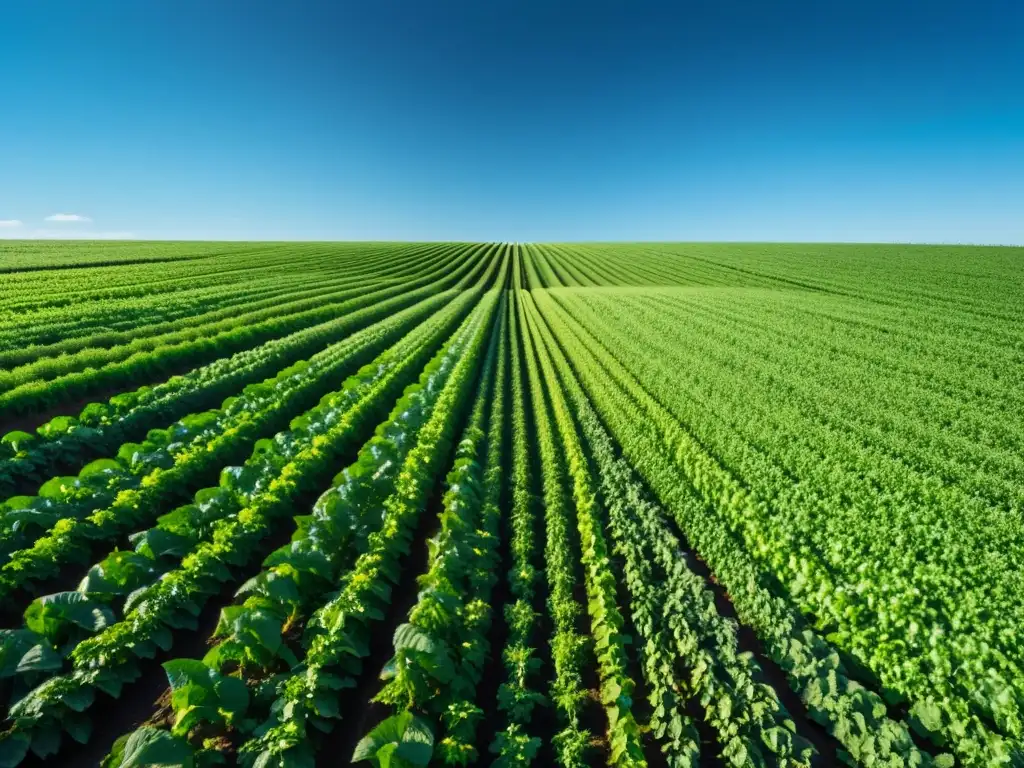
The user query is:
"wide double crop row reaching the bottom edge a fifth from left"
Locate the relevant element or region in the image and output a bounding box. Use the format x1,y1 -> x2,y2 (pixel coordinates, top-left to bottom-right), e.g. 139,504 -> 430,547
103,274 -> 501,765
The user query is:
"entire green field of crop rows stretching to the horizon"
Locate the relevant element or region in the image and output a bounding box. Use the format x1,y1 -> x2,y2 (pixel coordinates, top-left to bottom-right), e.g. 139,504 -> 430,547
0,242 -> 1024,768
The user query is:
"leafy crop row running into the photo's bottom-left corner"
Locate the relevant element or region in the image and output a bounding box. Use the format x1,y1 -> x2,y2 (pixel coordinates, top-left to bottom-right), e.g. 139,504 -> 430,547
4,257 -> 507,755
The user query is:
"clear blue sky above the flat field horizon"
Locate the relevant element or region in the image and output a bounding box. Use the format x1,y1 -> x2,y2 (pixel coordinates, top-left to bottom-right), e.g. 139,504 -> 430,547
0,0 -> 1024,244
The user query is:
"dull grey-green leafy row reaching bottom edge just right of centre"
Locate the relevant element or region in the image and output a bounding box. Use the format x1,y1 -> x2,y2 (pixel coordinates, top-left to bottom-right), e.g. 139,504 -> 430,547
527,290 -> 813,766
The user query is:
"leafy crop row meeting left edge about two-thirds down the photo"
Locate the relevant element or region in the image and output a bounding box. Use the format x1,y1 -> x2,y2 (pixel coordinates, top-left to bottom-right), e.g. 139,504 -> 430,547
0,280 -> 471,596
